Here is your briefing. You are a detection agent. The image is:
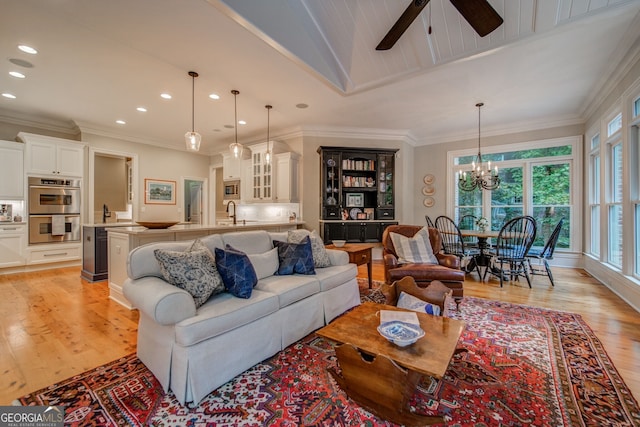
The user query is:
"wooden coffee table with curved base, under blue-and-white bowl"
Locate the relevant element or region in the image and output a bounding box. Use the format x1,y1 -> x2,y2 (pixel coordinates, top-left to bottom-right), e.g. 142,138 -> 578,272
316,302 -> 464,426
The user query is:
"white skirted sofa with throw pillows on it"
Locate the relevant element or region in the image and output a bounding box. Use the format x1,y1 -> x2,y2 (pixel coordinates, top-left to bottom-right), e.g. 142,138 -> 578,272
123,230 -> 360,404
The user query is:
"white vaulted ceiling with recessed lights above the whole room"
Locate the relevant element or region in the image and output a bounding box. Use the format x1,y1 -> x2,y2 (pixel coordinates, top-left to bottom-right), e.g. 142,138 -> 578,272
0,0 -> 640,154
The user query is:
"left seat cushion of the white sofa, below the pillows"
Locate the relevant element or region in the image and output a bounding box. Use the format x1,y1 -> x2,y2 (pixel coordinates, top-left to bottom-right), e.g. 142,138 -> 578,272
176,289 -> 278,347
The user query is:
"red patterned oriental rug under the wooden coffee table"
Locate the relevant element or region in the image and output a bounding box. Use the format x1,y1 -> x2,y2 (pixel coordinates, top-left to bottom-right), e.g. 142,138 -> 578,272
17,282 -> 640,427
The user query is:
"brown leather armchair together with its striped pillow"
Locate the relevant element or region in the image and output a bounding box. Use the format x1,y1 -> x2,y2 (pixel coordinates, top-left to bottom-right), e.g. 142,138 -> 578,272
382,225 -> 464,302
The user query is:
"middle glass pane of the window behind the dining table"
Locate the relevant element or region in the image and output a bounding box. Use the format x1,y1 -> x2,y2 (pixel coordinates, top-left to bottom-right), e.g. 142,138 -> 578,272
491,167 -> 523,230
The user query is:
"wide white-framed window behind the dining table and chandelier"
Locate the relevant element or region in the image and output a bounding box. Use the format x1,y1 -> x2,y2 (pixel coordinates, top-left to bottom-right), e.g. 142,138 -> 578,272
450,138 -> 576,250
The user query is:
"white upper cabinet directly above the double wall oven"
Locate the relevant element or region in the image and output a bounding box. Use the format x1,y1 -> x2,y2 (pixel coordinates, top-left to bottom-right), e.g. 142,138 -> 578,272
18,132 -> 85,178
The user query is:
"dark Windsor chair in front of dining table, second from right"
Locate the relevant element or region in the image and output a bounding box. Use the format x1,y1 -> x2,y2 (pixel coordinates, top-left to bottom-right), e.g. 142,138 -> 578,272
482,215 -> 537,287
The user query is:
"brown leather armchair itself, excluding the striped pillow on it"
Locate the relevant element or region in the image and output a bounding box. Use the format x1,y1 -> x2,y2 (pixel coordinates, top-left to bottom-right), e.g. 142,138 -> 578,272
382,225 -> 464,302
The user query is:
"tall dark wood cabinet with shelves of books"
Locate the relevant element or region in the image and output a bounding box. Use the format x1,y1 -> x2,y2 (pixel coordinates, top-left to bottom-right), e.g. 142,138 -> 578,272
318,147 -> 397,243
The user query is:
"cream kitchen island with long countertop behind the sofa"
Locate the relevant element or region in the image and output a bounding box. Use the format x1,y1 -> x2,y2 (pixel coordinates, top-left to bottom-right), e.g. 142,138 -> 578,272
106,220 -> 304,309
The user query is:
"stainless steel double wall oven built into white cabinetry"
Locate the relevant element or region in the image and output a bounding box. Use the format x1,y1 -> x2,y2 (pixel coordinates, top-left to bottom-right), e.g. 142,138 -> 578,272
29,177 -> 81,244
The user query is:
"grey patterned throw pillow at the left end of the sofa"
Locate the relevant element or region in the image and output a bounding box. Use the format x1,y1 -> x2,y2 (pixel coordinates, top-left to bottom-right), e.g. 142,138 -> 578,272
153,239 -> 224,308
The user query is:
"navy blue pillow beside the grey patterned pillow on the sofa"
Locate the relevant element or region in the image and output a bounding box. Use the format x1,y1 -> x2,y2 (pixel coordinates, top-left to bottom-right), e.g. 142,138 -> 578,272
215,245 -> 258,299
